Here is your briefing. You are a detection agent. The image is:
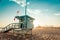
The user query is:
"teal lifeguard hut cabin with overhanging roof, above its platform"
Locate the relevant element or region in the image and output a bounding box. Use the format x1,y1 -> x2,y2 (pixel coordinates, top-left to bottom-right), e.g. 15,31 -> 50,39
15,15 -> 34,29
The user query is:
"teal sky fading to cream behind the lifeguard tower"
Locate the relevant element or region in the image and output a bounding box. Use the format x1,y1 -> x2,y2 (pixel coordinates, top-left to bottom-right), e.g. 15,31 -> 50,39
0,0 -> 60,27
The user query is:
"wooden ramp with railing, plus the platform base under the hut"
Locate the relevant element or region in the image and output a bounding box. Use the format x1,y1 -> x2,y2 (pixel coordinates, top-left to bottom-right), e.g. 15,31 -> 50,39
0,23 -> 32,33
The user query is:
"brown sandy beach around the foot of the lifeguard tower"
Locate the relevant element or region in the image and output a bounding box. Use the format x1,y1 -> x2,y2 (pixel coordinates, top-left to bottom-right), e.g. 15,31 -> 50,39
0,28 -> 60,40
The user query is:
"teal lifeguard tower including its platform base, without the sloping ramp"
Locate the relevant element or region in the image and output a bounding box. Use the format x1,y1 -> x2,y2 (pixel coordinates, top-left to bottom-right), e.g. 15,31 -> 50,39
14,15 -> 34,34
